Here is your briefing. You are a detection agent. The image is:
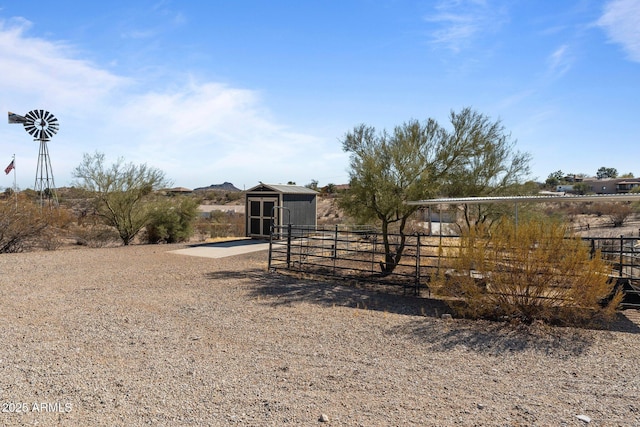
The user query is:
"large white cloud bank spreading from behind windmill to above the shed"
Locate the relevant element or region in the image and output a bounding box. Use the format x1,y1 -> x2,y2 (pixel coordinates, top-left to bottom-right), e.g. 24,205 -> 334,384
0,19 -> 346,188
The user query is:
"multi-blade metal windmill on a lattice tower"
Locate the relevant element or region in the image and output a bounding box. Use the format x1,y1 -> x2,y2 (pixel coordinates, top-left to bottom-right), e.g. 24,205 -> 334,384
9,110 -> 60,205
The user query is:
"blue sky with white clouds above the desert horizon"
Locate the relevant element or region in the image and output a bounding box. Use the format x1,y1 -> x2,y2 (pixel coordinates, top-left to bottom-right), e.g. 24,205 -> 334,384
0,0 -> 640,189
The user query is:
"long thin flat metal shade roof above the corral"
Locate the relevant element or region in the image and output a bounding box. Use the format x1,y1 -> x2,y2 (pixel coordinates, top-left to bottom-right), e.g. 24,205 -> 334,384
406,193 -> 640,206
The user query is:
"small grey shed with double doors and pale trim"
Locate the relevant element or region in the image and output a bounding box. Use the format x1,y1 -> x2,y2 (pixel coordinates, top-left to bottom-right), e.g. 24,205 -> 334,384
245,183 -> 318,238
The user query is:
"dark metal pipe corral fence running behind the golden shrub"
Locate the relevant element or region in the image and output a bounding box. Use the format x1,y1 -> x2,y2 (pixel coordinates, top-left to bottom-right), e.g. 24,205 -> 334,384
268,224 -> 640,308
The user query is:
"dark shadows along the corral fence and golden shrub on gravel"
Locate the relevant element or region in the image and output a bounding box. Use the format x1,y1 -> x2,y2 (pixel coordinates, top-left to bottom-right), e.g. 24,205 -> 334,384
202,269 -> 640,358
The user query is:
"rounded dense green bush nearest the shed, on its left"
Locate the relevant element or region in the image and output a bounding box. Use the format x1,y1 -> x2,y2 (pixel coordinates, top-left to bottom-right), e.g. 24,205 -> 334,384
143,197 -> 198,243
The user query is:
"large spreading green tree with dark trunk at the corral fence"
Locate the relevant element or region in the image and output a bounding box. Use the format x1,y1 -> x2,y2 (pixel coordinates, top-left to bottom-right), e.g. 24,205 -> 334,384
338,108 -> 528,274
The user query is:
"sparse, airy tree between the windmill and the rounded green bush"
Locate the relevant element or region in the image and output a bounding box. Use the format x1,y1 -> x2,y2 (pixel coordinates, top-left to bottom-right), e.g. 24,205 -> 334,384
74,152 -> 169,245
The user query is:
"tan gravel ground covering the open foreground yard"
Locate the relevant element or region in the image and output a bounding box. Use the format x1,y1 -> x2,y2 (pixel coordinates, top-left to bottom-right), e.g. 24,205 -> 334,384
0,245 -> 640,426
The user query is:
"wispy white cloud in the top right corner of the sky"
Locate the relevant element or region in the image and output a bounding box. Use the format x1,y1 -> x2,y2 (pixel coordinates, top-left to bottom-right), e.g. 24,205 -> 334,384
598,0 -> 640,62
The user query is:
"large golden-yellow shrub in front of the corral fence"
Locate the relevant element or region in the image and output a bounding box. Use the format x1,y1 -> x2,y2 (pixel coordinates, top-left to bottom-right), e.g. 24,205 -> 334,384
438,220 -> 622,324
